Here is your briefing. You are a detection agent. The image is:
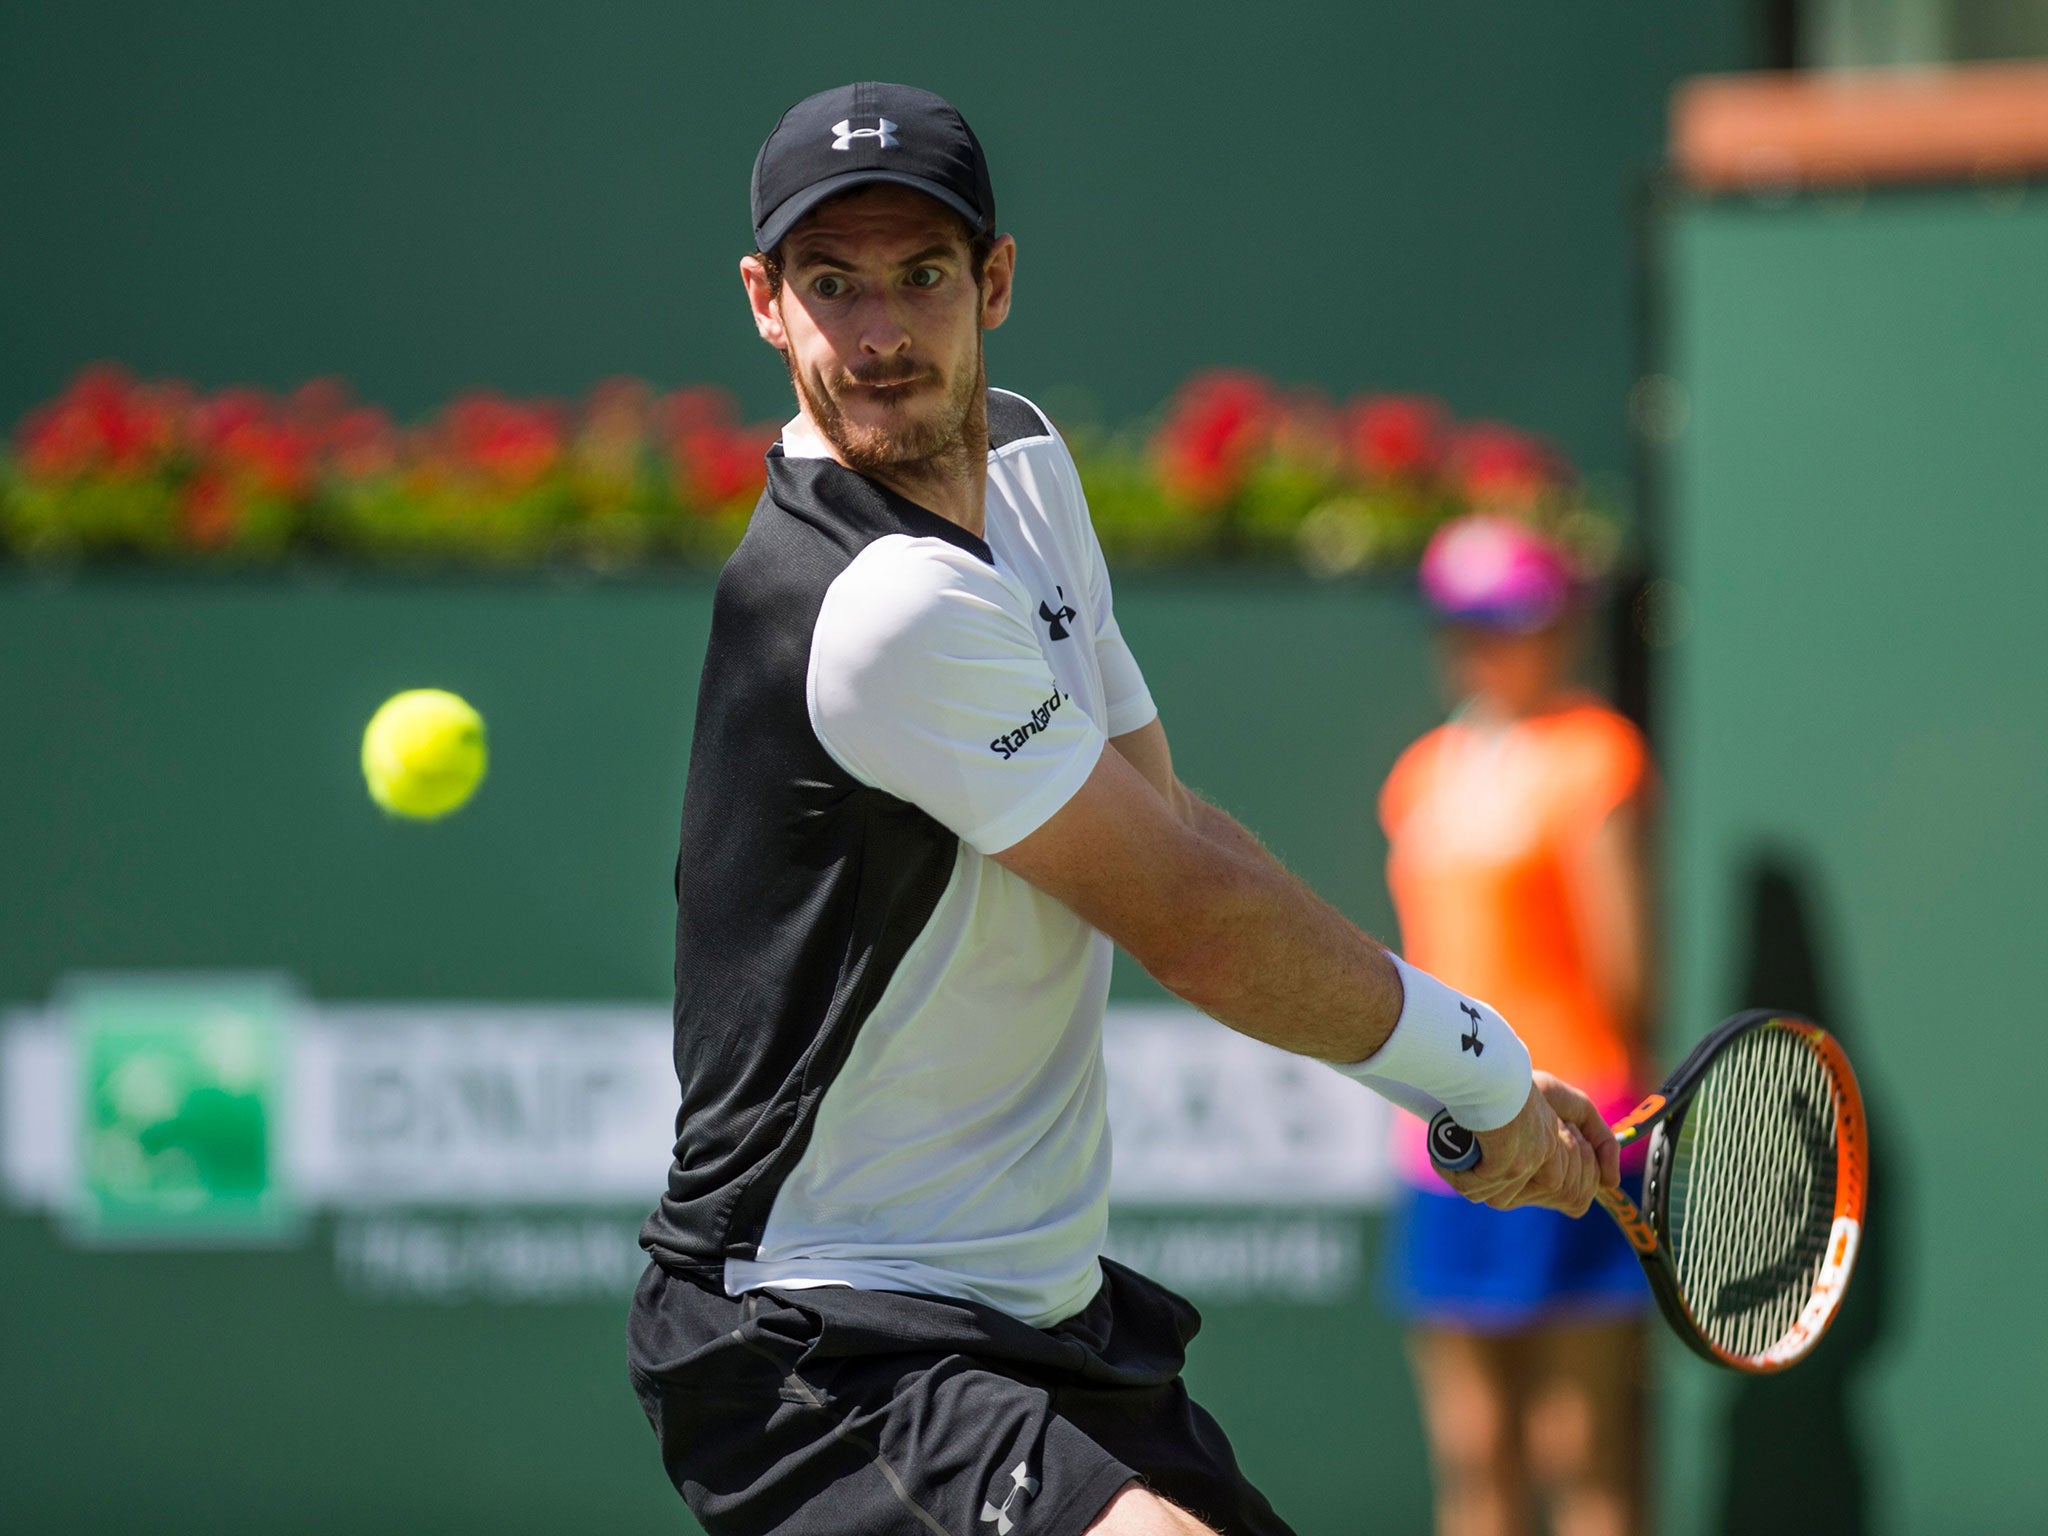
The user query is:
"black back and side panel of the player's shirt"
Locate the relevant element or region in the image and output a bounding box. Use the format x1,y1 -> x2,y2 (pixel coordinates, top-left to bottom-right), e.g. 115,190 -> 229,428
641,453 -> 958,1268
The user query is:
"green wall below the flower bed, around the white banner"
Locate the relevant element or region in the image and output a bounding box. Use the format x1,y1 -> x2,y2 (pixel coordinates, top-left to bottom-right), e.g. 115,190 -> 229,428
0,573 -> 1440,1536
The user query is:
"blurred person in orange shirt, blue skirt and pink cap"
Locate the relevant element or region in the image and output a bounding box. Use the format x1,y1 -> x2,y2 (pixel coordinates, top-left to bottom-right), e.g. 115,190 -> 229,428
1380,516 -> 1651,1536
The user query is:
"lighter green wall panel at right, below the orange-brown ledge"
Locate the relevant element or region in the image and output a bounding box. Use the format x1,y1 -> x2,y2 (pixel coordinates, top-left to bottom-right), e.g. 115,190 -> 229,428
1663,184 -> 2048,1536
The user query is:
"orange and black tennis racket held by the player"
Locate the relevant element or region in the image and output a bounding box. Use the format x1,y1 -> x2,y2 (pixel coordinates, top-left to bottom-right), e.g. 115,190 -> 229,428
1430,1010 -> 1870,1372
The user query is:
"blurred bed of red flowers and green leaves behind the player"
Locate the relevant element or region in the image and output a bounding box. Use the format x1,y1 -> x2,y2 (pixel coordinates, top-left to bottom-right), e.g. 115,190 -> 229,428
0,367 -> 1614,575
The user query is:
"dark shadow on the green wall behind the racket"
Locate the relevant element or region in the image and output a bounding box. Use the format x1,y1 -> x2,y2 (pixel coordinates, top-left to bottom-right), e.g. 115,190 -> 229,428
1718,850 -> 1907,1536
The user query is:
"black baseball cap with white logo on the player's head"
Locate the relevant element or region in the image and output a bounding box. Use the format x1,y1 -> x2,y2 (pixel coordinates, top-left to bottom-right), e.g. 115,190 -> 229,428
754,80 -> 995,250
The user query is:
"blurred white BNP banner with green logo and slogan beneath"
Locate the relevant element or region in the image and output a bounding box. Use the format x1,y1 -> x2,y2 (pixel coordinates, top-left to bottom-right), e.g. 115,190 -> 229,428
0,977 -> 1389,1298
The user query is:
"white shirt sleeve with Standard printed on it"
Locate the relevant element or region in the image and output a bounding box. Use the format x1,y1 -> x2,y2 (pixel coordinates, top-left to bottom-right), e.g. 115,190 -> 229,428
805,535 -> 1104,854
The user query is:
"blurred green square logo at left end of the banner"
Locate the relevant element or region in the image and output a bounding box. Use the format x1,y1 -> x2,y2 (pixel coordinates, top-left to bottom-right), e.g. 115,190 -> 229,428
66,977 -> 295,1245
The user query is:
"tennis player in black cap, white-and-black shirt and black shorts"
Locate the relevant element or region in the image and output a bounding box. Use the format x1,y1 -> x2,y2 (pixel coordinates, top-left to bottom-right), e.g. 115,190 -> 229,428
629,84 -> 1616,1536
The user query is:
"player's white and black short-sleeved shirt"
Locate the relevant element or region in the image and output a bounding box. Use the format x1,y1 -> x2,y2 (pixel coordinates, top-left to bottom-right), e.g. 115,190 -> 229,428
641,389 -> 1155,1327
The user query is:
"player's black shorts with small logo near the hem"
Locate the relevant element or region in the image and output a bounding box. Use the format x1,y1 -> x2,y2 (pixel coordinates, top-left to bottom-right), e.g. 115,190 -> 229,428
627,1260 -> 1290,1536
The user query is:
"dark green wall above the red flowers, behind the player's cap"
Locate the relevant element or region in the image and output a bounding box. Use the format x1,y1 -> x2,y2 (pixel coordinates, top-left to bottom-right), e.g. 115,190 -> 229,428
0,0 -> 1751,473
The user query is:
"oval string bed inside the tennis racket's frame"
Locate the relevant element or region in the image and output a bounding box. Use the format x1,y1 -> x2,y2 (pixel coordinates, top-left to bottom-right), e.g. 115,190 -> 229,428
1669,1026 -> 1835,1356
